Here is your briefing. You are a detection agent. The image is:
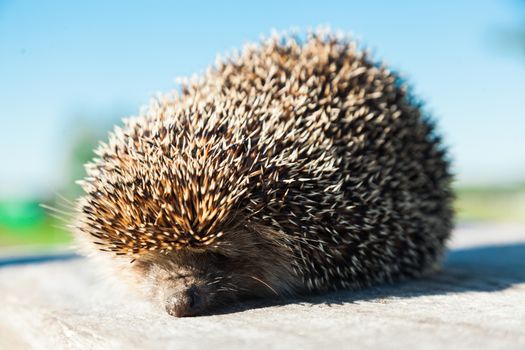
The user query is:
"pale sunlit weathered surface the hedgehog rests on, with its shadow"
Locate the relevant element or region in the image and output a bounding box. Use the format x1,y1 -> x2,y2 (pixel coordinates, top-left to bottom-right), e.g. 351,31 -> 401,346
0,225 -> 525,350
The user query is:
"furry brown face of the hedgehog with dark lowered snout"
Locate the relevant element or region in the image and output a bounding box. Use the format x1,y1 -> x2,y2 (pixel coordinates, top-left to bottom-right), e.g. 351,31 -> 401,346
134,230 -> 296,317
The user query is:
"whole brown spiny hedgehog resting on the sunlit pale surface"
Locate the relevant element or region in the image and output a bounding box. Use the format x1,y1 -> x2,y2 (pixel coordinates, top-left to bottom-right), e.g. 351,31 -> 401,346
75,33 -> 452,316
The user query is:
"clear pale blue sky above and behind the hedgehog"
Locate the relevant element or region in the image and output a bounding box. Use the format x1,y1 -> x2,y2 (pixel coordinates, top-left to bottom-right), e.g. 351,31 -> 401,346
0,0 -> 525,197
